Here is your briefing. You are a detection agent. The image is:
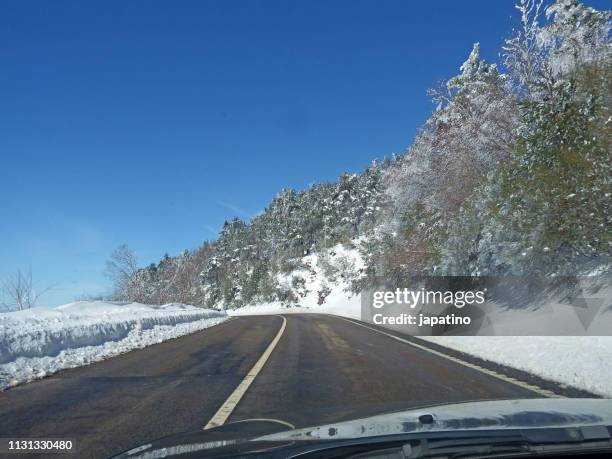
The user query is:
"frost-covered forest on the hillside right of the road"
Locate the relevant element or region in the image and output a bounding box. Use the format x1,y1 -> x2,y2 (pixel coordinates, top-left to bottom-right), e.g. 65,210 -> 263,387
108,0 -> 612,308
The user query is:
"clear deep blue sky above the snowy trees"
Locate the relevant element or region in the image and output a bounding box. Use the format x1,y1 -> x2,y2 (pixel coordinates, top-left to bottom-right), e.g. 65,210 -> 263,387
0,0 -> 604,305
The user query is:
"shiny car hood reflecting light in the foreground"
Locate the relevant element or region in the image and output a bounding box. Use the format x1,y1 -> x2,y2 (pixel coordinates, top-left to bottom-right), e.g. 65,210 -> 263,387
115,398 -> 612,459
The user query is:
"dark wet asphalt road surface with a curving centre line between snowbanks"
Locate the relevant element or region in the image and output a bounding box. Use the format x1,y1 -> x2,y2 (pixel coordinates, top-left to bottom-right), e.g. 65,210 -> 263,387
0,314 -> 584,458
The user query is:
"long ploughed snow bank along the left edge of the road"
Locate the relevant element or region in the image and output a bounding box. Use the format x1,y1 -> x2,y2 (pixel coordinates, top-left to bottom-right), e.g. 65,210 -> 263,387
0,301 -> 227,390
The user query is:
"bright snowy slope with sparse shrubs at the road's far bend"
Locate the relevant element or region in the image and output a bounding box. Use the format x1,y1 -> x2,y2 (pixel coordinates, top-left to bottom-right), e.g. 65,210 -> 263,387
227,244 -> 363,319
